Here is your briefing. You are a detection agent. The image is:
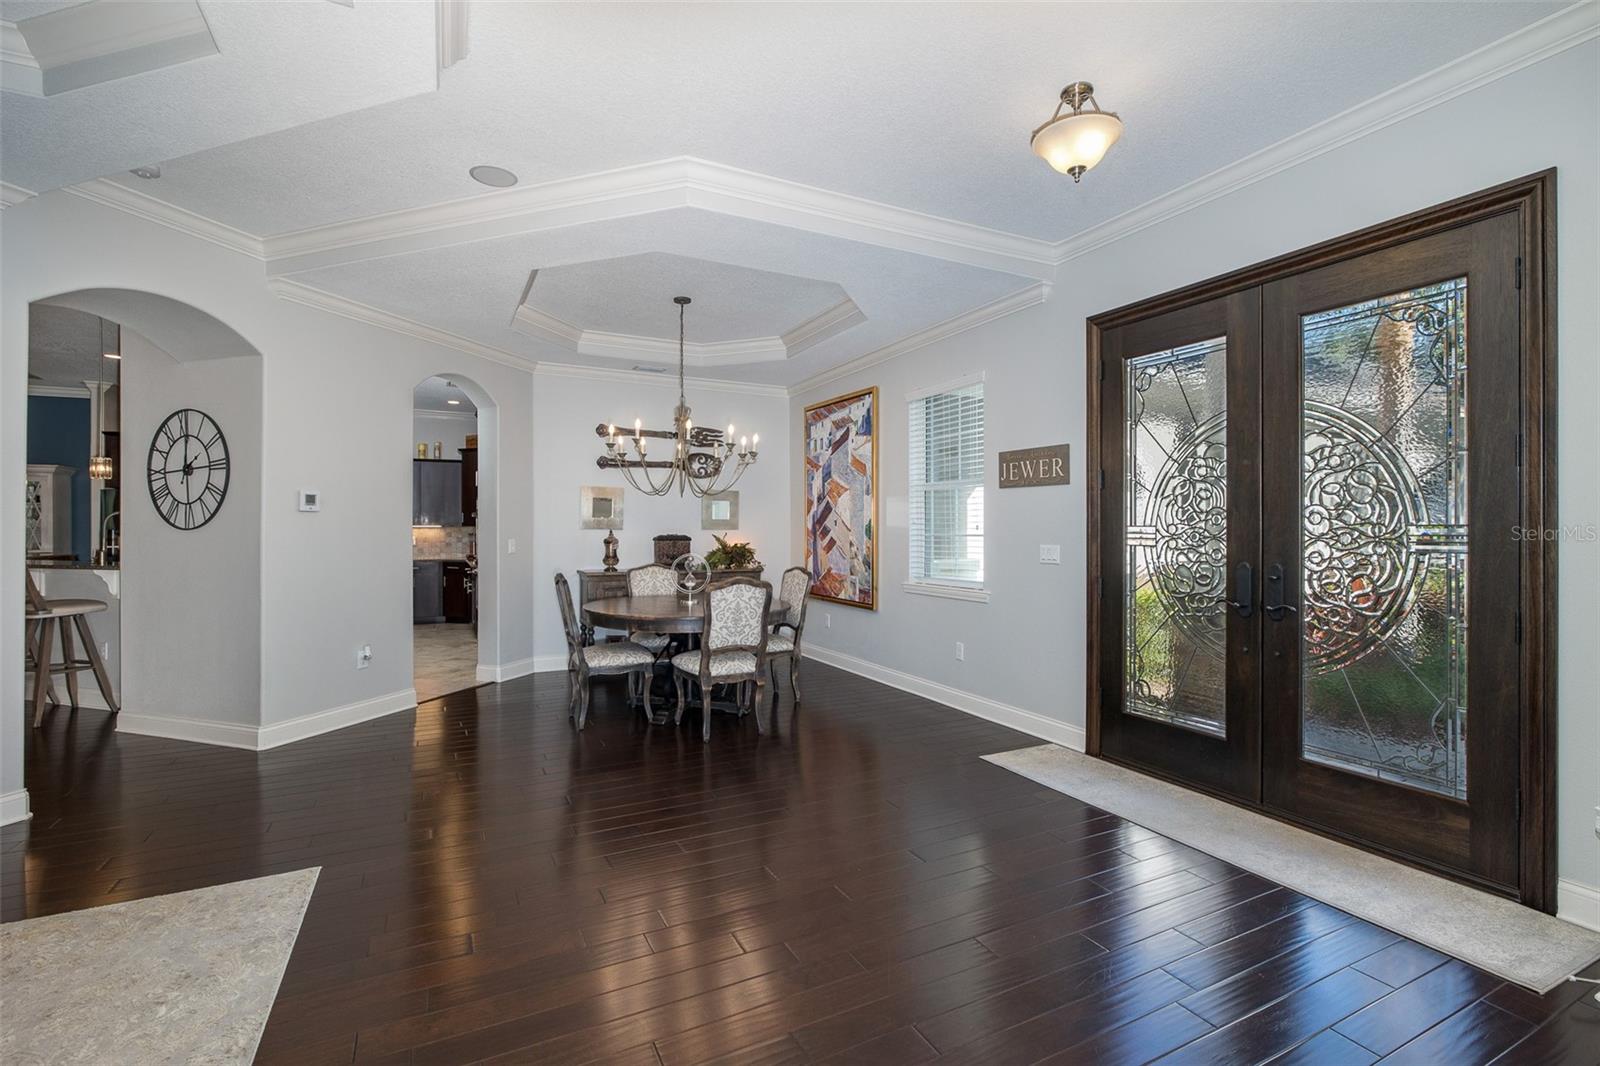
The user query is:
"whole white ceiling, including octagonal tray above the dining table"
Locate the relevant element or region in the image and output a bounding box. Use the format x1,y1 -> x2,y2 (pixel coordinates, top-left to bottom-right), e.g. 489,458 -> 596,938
0,0 -> 1562,386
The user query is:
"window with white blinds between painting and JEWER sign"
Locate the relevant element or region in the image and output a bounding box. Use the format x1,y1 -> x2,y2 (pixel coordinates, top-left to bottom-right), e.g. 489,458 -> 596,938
909,379 -> 984,587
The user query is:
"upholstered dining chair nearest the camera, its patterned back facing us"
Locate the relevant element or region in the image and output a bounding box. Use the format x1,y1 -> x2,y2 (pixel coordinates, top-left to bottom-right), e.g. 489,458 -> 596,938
672,578 -> 773,741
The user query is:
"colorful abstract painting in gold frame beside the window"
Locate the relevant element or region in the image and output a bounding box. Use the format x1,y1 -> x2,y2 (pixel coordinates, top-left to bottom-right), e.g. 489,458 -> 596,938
803,389 -> 878,610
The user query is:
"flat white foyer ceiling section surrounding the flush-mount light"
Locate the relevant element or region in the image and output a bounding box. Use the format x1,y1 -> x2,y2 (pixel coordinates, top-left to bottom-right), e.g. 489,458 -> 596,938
90,2 -> 1562,240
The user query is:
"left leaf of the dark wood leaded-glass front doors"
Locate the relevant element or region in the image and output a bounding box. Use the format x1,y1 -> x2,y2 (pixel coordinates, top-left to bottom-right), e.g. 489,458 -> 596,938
1099,291 -> 1261,802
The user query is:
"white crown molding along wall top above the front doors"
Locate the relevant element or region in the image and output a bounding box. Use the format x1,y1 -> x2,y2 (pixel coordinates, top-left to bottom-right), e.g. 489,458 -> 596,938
1054,0 -> 1600,264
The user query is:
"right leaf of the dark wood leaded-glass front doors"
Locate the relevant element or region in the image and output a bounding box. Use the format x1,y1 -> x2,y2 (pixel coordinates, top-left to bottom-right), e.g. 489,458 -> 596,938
1261,214 -> 1520,887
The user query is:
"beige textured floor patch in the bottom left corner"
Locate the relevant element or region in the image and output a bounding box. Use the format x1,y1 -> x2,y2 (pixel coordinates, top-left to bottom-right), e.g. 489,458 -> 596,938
0,868 -> 320,1066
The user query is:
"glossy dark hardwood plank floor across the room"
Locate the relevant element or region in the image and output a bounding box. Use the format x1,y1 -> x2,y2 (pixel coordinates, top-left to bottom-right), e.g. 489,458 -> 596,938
0,663 -> 1600,1066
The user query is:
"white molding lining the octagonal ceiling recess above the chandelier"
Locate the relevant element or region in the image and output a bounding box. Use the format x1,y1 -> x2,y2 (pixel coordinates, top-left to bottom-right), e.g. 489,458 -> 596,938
510,292 -> 867,367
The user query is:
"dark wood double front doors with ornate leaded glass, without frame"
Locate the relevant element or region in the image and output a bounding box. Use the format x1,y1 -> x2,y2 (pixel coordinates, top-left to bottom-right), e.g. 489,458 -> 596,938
1096,186 -> 1525,896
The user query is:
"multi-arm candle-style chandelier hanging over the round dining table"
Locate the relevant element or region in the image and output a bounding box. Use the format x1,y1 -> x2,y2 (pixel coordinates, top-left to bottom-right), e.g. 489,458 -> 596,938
595,296 -> 762,496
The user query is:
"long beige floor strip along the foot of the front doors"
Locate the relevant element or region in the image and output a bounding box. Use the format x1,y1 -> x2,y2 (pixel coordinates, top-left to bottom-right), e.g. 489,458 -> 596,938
984,744 -> 1600,992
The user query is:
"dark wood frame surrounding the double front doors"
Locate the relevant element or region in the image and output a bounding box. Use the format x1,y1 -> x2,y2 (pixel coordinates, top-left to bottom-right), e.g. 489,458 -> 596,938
1085,168 -> 1560,914
